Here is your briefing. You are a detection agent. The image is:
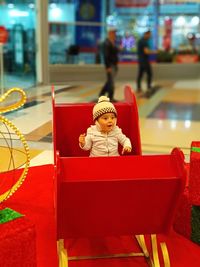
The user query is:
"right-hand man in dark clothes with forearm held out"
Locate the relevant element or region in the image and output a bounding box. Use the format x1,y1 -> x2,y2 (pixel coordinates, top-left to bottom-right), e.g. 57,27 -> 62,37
136,30 -> 157,97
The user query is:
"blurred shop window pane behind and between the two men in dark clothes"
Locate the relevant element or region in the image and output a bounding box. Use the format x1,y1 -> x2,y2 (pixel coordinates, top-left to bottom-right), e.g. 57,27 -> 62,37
111,0 -> 157,63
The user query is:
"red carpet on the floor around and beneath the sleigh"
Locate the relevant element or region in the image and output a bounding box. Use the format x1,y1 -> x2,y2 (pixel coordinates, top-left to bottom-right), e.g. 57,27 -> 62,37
2,165 -> 200,267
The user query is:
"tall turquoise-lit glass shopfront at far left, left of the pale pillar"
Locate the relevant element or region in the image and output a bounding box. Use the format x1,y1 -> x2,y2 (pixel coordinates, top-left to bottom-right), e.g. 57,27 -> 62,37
0,0 -> 36,88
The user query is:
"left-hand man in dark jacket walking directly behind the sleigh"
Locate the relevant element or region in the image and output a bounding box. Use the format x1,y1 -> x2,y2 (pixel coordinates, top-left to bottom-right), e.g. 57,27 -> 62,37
99,30 -> 119,102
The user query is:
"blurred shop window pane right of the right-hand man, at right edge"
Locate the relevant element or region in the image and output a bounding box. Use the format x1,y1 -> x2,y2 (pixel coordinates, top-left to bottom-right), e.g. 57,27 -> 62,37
158,1 -> 200,62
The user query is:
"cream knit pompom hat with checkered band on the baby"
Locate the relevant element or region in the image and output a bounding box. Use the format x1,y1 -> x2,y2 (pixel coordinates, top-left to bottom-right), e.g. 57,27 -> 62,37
92,96 -> 117,121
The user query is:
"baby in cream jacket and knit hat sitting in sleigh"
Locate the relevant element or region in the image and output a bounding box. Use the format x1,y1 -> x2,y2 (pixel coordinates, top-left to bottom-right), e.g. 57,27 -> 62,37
79,96 -> 132,157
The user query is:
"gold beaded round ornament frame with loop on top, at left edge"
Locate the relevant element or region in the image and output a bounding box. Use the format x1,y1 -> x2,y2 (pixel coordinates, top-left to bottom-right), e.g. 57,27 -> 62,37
0,88 -> 30,203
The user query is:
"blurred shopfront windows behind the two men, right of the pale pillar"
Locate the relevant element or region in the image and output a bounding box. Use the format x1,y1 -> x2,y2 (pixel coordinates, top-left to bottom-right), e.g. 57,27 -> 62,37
49,0 -> 200,64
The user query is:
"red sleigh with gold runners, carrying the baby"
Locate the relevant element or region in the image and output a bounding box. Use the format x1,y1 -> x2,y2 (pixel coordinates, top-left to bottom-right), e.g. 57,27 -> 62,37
53,86 -> 200,267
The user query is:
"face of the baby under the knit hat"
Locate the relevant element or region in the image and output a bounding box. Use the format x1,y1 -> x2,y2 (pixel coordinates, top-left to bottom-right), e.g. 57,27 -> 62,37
97,113 -> 117,133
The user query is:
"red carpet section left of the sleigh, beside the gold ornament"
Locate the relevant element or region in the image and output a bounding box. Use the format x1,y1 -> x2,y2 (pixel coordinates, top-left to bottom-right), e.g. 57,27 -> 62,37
4,165 -> 58,267
